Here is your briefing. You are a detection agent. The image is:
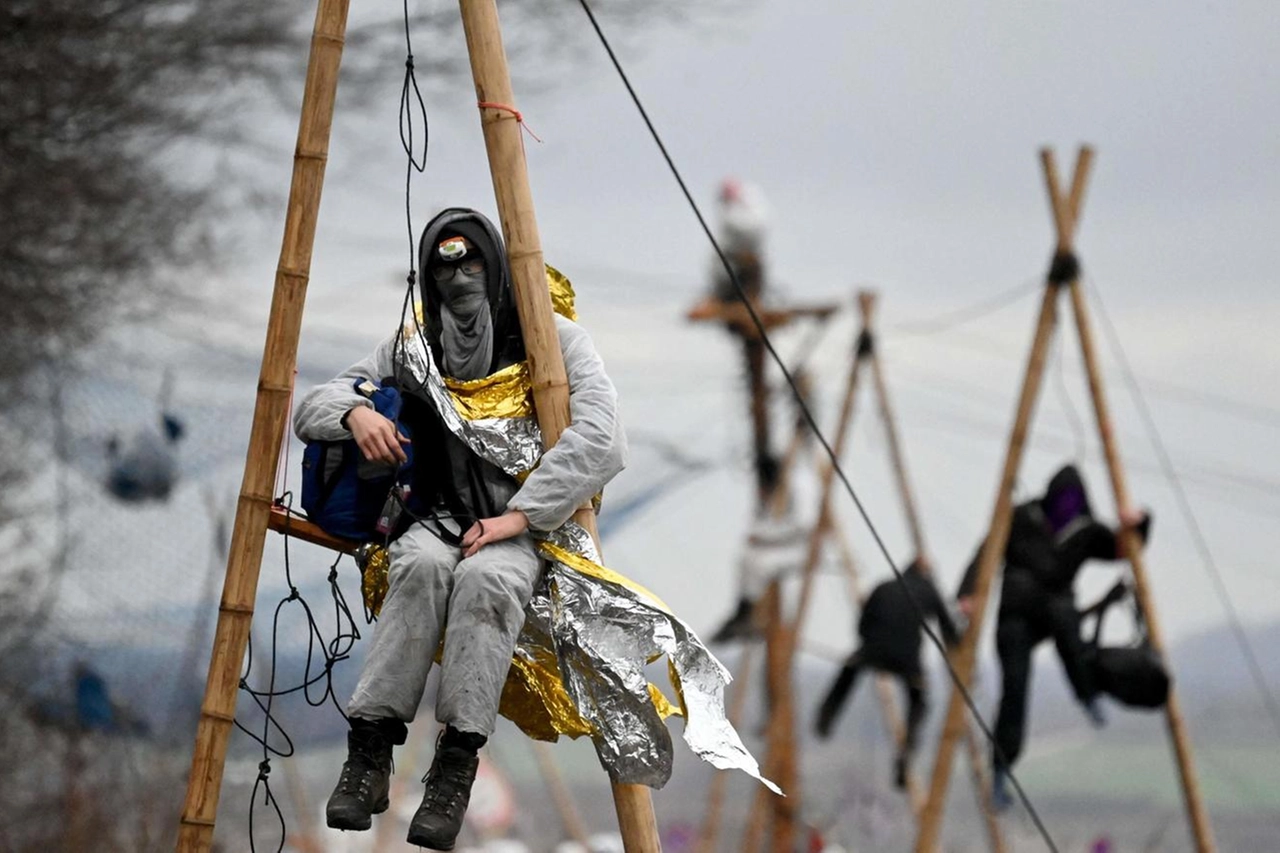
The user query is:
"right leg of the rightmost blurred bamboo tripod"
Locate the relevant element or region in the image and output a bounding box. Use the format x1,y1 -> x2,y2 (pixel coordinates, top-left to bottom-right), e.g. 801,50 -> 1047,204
1070,280 -> 1216,853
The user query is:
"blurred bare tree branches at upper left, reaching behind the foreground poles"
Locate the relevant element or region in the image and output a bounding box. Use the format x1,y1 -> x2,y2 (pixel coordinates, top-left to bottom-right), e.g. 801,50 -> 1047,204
0,0 -> 742,392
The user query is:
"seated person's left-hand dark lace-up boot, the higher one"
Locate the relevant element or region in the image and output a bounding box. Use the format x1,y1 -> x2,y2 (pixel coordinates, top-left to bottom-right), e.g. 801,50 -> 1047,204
325,717 -> 406,830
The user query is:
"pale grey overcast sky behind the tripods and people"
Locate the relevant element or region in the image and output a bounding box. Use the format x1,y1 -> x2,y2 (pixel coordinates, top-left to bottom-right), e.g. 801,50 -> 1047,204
197,0 -> 1280,666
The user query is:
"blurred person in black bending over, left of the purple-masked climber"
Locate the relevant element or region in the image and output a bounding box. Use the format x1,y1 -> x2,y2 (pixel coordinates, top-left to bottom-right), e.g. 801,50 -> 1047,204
814,558 -> 959,788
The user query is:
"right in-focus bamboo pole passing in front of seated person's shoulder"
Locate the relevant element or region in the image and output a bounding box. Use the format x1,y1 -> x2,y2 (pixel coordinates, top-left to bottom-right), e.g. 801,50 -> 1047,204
458,0 -> 662,853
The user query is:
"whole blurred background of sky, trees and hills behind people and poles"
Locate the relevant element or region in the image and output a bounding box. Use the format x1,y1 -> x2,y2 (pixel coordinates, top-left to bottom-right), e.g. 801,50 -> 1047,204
0,0 -> 1280,852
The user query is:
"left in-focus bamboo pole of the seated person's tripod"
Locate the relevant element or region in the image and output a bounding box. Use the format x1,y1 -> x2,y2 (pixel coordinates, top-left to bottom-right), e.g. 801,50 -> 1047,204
177,0 -> 348,853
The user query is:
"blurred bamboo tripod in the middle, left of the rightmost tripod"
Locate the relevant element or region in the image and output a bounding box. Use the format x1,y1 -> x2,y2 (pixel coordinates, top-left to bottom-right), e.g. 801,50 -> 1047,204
742,291 -> 1005,853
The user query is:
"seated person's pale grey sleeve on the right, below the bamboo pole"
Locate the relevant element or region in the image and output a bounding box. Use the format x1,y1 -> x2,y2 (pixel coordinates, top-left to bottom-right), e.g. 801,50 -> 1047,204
507,315 -> 627,530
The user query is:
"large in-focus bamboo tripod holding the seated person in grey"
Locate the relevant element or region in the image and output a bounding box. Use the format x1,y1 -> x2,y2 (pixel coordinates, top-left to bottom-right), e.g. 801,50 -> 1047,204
177,0 -> 662,853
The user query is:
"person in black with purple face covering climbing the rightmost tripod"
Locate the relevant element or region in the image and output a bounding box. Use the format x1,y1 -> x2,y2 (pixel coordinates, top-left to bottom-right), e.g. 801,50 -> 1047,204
957,465 -> 1151,808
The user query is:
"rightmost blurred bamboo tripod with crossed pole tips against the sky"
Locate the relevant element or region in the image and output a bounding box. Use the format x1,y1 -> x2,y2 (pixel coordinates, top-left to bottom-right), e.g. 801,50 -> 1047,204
915,146 -> 1215,853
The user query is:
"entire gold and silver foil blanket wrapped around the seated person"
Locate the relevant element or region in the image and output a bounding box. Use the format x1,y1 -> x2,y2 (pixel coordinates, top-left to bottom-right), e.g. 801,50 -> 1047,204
364,266 -> 778,792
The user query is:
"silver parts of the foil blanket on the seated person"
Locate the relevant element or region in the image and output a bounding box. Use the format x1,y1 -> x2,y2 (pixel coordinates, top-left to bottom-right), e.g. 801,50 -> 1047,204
397,326 -> 781,793
